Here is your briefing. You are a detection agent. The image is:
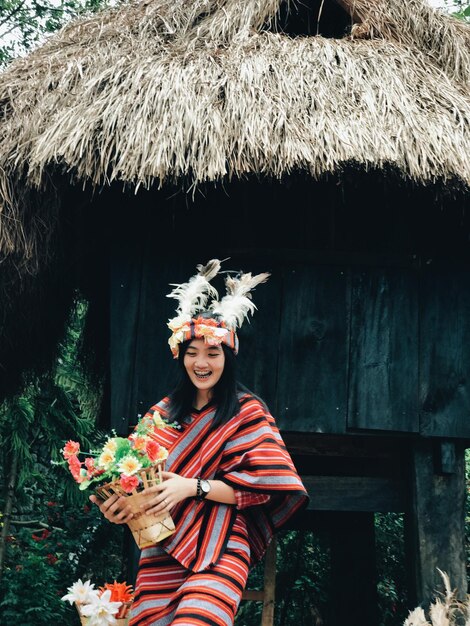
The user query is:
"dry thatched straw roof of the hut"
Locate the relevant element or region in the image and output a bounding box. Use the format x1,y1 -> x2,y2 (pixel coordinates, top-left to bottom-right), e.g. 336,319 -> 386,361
0,0 -> 470,394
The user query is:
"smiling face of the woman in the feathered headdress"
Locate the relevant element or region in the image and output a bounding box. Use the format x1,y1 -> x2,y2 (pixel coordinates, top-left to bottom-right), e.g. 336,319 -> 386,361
183,339 -> 225,391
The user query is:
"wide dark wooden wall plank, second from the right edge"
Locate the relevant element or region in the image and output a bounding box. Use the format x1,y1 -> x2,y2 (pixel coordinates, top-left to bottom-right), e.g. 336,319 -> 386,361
348,269 -> 419,432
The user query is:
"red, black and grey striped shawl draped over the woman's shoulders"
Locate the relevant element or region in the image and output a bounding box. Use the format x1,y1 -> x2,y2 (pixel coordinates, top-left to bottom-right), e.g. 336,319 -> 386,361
150,394 -> 308,572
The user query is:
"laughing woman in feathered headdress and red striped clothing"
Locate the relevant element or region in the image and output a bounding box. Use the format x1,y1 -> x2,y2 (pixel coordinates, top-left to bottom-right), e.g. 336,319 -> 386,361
92,259 -> 308,626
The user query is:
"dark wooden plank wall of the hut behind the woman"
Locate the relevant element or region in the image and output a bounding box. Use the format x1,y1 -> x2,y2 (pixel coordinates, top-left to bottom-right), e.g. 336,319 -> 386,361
105,173 -> 470,438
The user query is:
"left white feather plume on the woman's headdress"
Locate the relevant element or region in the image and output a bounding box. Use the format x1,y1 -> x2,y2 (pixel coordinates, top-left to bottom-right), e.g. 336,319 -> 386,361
167,259 -> 220,317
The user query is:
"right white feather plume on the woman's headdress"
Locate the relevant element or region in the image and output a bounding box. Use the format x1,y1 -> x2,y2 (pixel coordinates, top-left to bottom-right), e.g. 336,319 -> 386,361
211,272 -> 270,330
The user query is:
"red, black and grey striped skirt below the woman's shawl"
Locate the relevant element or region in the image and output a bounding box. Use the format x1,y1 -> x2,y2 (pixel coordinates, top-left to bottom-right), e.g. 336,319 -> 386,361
130,515 -> 250,626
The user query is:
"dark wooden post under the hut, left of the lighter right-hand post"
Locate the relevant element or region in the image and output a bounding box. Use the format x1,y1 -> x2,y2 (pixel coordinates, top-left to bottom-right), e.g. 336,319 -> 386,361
328,513 -> 379,626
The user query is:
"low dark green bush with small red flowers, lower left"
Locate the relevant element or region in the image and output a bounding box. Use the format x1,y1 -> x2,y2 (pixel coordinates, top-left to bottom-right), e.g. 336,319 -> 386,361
0,483 -> 125,626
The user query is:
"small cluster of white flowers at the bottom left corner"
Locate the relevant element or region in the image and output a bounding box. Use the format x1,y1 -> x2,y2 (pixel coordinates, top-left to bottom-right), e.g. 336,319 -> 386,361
62,580 -> 122,626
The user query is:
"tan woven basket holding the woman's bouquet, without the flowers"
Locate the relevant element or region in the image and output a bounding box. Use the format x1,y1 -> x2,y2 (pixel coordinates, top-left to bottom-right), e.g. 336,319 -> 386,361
95,463 -> 175,549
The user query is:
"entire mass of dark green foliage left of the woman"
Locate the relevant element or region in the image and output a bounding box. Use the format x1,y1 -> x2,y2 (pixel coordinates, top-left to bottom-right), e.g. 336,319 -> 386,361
0,303 -> 126,626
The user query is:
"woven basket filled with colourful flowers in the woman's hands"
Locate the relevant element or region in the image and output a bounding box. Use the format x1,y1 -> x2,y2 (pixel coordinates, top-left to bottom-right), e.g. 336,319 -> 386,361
62,411 -> 175,548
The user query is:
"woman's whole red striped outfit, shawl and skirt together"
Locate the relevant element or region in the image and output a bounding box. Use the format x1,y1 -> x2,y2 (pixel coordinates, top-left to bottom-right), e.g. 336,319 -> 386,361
130,394 -> 308,626
